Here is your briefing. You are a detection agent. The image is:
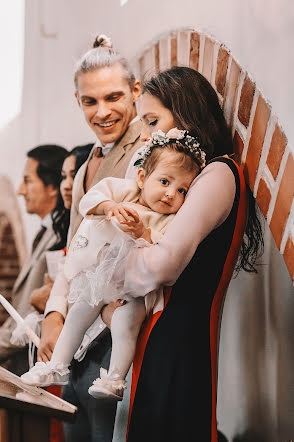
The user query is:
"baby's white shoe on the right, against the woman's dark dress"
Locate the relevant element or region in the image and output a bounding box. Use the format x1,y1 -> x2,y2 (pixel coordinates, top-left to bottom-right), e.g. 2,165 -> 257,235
88,368 -> 127,401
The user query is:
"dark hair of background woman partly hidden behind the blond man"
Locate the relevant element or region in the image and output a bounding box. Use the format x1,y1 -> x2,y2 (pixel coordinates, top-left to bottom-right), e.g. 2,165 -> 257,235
50,144 -> 93,250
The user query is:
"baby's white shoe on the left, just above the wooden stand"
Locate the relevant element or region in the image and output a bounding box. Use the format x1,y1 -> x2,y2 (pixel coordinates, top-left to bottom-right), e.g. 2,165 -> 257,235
20,361 -> 69,387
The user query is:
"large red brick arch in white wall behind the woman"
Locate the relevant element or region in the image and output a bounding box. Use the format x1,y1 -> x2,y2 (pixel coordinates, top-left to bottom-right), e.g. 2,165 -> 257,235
134,29 -> 294,281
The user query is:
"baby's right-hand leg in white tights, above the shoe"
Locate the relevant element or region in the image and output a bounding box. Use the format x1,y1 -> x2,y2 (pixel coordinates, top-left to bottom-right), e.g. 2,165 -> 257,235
108,297 -> 146,379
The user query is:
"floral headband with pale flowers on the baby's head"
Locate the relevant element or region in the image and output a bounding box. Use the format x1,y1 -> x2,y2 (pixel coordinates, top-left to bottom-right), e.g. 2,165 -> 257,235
134,127 -> 206,169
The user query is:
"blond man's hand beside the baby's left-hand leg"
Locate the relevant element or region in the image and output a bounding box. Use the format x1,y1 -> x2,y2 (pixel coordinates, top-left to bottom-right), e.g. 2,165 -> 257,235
37,312 -> 64,362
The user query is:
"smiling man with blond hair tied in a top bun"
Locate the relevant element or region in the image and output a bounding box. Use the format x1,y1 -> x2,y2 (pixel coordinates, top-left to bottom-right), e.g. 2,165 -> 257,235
38,36 -> 142,442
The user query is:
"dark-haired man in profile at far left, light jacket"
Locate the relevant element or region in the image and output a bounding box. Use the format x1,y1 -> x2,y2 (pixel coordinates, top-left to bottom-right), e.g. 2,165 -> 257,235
0,145 -> 67,375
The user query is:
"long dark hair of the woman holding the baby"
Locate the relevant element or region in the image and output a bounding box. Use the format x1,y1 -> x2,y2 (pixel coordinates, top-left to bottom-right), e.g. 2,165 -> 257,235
142,66 -> 263,273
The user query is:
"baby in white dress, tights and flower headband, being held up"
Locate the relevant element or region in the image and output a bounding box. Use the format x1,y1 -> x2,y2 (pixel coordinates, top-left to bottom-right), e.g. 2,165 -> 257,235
21,129 -> 205,400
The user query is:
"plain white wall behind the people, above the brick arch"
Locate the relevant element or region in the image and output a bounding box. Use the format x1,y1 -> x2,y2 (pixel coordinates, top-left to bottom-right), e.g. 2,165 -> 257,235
0,0 -> 294,249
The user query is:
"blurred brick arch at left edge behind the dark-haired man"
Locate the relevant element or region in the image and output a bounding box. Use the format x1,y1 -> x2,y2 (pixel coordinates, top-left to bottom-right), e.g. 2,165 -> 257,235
0,177 -> 26,325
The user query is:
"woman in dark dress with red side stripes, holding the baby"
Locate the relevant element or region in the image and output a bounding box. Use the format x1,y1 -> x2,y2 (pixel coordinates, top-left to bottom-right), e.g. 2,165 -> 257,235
103,67 -> 263,442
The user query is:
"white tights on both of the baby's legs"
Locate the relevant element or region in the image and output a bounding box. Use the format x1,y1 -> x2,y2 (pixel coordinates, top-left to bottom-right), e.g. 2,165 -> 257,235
51,298 -> 146,379
